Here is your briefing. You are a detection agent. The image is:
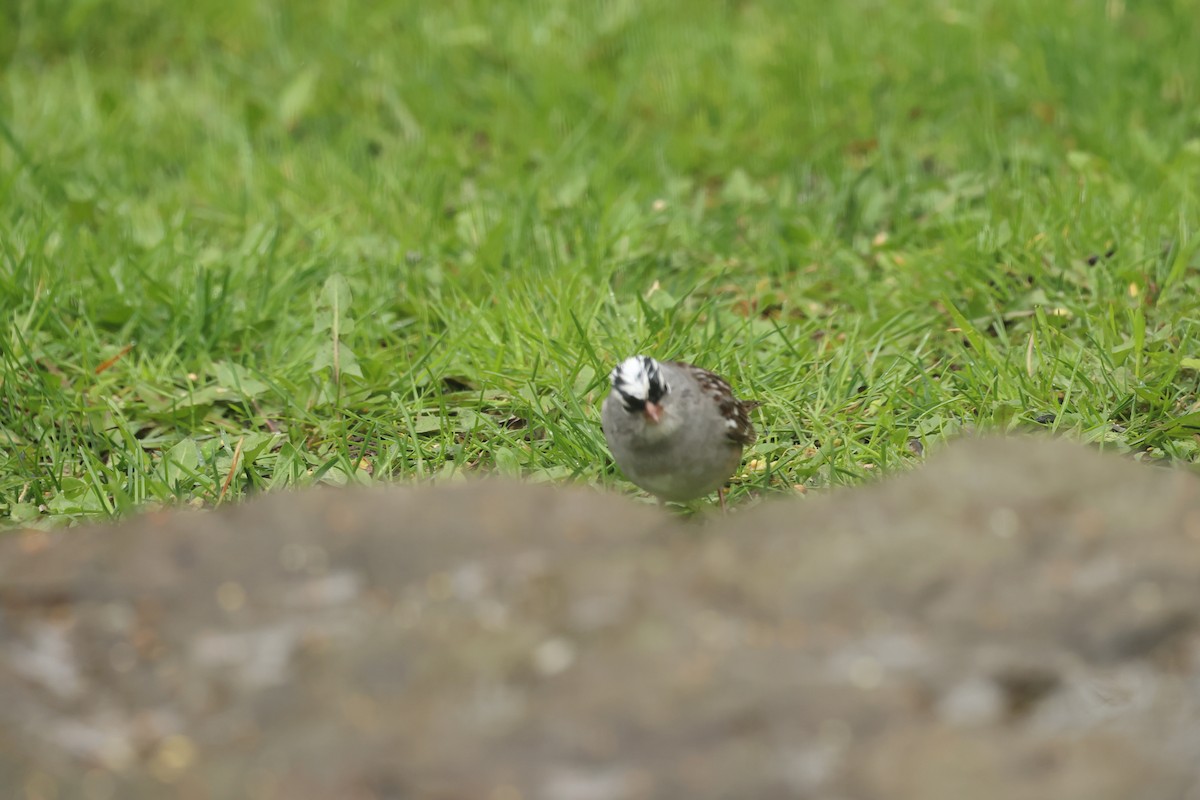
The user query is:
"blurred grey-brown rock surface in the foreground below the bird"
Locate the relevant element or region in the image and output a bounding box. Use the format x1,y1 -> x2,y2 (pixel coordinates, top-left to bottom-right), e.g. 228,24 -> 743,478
0,440 -> 1200,800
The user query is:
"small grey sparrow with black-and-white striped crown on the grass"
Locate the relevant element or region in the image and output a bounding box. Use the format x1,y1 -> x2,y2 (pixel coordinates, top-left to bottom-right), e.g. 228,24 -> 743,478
600,355 -> 755,509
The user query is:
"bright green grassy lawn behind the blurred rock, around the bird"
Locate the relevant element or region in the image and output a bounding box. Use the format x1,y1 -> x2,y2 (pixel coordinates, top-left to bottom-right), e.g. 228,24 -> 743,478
0,0 -> 1200,525
